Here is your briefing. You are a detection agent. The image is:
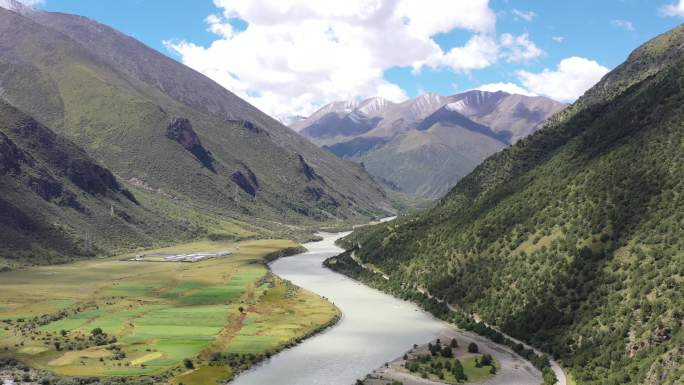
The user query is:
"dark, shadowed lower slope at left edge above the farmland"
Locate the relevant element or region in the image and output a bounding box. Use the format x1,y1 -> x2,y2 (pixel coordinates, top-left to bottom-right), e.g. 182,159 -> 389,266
0,101 -> 219,267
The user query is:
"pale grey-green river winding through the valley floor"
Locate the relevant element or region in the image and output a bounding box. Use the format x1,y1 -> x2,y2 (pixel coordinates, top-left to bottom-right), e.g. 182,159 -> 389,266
233,234 -> 447,385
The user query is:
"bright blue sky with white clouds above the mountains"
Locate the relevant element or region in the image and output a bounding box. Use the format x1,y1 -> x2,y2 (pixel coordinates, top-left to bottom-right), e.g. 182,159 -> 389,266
37,0 -> 684,118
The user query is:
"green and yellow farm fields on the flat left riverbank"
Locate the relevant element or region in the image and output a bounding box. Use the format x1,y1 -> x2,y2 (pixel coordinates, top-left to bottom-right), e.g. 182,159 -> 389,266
0,240 -> 338,385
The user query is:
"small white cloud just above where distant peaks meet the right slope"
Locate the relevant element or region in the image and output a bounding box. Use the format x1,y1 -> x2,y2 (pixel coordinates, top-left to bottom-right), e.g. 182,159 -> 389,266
518,56 -> 609,102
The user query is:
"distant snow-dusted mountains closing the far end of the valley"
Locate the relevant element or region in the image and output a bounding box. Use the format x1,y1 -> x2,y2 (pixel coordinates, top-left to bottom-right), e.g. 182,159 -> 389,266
290,91 -> 564,198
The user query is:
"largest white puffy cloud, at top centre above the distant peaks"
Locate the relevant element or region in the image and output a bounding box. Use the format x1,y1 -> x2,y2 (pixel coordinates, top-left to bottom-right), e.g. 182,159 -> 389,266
165,0 -> 541,119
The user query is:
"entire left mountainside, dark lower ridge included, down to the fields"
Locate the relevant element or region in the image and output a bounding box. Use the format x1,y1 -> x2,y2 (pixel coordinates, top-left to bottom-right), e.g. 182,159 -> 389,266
0,0 -> 393,267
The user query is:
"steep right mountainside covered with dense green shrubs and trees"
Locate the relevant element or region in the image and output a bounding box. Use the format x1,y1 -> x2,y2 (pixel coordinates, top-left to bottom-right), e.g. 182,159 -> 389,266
336,26 -> 684,385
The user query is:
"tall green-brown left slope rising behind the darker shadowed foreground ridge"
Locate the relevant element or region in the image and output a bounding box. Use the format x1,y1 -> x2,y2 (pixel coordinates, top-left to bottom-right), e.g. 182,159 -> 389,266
0,1 -> 391,234
